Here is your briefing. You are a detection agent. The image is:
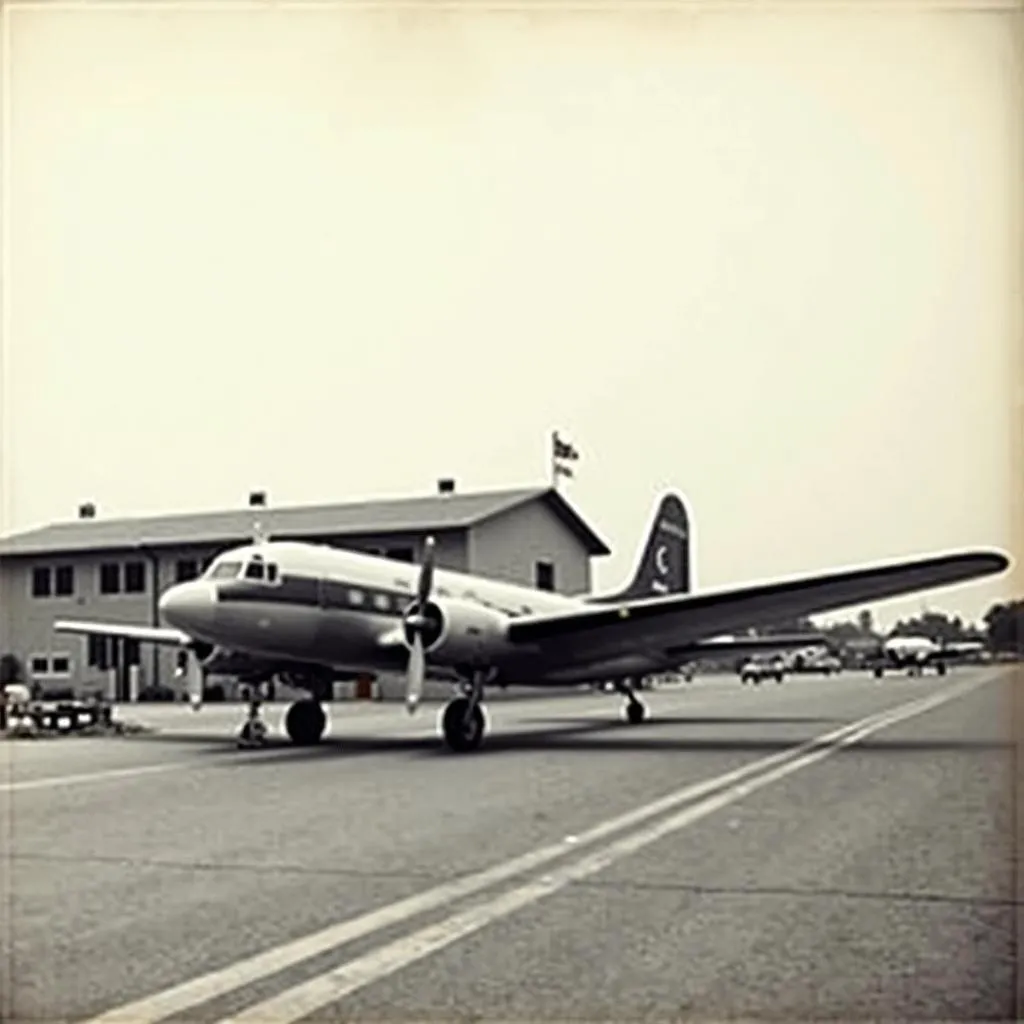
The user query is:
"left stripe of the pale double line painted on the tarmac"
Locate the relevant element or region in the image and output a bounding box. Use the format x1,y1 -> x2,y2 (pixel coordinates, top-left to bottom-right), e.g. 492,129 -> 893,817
79,683 -> 981,1024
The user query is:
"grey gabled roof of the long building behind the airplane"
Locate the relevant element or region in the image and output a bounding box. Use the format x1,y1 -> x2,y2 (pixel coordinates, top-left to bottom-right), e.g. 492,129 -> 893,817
0,487 -> 610,557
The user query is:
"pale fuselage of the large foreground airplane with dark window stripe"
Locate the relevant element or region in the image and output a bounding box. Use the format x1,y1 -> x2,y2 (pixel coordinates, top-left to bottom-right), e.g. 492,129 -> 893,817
161,541 -> 678,684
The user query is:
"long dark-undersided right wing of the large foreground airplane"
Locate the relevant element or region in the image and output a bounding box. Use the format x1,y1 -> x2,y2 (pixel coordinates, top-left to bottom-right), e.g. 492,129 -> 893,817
508,551 -> 1010,660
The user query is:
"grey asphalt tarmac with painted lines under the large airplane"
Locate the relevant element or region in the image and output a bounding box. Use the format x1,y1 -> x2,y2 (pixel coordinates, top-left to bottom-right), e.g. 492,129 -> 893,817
0,668 -> 1024,1024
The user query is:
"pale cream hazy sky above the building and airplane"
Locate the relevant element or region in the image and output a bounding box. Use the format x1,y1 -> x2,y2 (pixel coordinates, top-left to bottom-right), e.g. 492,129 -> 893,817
0,2 -> 1024,622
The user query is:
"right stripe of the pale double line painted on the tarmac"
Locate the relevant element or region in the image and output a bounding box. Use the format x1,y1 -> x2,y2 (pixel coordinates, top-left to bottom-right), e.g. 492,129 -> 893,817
226,682 -> 981,1024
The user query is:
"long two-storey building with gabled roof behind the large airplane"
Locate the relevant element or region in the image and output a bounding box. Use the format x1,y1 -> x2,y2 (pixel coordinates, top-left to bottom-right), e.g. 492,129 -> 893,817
0,480 -> 610,699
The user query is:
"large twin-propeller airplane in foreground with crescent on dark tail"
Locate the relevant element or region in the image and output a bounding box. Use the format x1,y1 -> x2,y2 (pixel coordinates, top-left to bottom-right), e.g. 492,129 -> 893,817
54,493 -> 1010,752
